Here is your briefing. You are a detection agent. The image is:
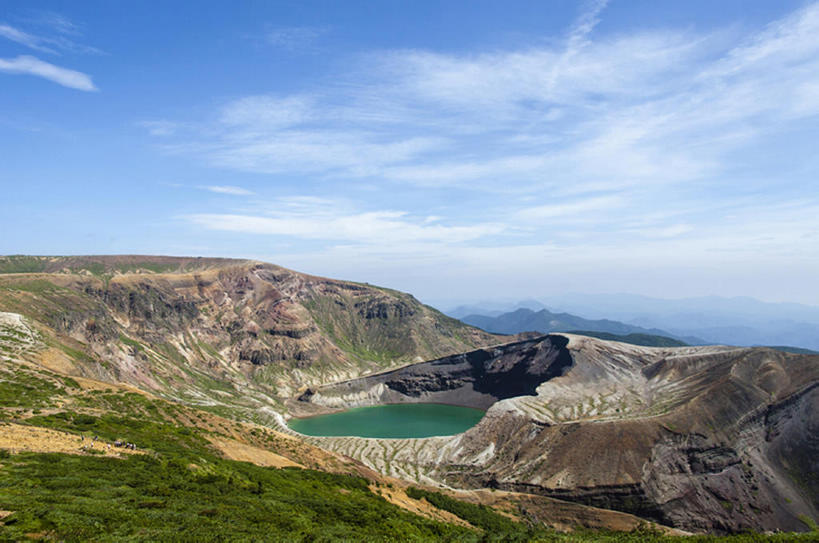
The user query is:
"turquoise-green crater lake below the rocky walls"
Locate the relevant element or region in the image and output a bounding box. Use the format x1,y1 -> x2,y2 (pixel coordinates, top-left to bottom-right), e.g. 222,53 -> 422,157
287,403 -> 484,438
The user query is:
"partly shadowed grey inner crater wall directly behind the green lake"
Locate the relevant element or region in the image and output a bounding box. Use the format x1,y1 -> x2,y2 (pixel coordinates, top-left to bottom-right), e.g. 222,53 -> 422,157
297,336 -> 572,409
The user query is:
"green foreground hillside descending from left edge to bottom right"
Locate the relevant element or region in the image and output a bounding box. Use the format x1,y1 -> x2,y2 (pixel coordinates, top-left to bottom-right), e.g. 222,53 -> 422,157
0,384 -> 815,543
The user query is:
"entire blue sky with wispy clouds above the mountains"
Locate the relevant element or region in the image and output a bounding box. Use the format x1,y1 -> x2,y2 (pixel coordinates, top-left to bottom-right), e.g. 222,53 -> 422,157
0,0 -> 819,305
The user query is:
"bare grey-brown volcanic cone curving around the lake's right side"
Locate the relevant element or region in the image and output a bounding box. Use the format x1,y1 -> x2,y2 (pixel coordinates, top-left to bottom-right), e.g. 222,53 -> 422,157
293,335 -> 819,532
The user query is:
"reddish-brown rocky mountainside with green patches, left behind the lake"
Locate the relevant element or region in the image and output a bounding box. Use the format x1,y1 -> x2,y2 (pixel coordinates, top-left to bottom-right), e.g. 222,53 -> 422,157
0,256 -> 499,406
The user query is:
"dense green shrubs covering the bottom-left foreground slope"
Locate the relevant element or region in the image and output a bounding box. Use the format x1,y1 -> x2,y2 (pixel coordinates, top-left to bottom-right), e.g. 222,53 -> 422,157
0,413 -> 478,541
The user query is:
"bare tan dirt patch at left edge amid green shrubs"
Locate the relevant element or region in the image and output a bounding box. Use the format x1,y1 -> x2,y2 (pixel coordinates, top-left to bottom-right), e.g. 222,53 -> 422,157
0,423 -> 142,456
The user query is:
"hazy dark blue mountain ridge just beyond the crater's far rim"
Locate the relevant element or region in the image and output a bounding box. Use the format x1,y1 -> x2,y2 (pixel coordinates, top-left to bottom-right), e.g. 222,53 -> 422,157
461,308 -> 705,344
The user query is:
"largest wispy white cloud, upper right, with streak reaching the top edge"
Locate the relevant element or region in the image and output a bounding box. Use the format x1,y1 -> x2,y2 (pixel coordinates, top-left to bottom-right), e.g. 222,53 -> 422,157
163,2 -> 819,196
